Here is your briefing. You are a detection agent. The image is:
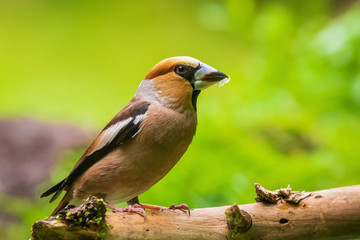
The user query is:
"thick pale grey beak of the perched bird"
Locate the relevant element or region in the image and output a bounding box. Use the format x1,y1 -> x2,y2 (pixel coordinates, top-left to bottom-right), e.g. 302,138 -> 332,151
194,63 -> 229,90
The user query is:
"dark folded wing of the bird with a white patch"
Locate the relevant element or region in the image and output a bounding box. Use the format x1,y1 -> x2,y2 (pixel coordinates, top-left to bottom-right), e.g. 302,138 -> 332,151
41,99 -> 150,202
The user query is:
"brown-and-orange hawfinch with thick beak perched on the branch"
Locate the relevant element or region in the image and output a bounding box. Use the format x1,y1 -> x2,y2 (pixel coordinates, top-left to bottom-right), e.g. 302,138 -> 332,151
41,57 -> 229,215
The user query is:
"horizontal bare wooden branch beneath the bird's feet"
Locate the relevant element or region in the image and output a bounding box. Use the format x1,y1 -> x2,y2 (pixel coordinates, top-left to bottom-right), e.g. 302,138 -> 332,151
32,185 -> 360,240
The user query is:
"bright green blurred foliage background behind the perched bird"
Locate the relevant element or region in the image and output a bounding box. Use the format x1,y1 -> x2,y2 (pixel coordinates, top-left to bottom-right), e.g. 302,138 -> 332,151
0,0 -> 360,239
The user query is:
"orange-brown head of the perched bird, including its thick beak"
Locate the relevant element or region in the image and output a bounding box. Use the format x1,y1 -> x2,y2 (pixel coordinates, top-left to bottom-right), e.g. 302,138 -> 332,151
136,57 -> 228,111
